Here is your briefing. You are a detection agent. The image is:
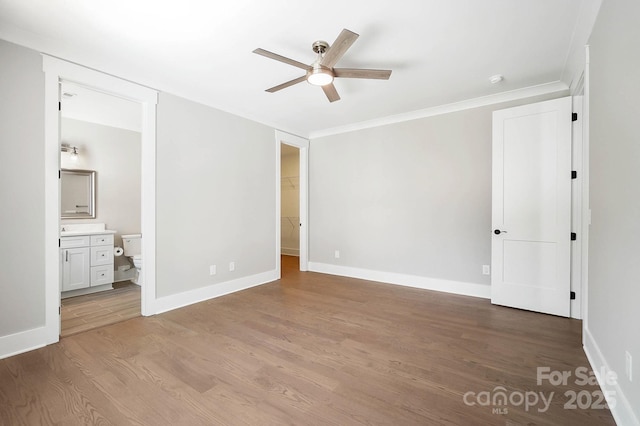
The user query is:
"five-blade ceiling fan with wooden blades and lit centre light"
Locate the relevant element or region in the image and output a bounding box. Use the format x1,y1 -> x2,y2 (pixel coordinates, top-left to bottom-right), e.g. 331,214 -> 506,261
253,28 -> 391,102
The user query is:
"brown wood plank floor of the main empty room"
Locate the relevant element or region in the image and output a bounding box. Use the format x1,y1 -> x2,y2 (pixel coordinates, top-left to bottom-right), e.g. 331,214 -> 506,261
0,258 -> 614,425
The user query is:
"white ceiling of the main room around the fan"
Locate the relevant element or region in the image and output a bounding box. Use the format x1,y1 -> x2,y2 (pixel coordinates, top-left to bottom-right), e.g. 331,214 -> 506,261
0,0 -> 601,136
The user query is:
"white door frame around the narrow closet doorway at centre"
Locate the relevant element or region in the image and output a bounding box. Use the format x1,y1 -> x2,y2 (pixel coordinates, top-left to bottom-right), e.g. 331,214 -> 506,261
275,130 -> 309,272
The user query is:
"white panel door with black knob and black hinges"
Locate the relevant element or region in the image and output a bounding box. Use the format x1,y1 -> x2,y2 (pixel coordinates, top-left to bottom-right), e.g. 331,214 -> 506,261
491,97 -> 571,317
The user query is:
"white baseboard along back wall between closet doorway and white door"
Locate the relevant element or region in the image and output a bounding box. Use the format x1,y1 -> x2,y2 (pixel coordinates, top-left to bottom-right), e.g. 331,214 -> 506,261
309,262 -> 491,299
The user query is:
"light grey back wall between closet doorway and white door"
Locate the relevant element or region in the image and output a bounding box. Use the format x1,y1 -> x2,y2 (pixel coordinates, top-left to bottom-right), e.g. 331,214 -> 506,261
309,93 -> 565,295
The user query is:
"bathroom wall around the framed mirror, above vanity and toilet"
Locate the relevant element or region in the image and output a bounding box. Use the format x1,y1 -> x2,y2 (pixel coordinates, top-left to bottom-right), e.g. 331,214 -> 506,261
61,118 -> 142,267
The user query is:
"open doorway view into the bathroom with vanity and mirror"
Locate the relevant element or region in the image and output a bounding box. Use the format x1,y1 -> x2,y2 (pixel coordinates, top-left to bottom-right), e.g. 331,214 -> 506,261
60,80 -> 142,337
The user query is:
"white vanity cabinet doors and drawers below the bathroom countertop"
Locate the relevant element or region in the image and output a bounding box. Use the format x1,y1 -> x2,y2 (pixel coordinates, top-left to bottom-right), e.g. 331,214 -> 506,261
60,234 -> 113,297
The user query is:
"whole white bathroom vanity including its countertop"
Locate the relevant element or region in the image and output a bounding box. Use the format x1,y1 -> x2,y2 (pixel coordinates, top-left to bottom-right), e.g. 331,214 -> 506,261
60,224 -> 116,299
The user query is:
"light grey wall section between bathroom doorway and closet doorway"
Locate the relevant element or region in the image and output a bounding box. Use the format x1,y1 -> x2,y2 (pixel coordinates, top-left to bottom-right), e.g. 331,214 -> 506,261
156,93 -> 276,297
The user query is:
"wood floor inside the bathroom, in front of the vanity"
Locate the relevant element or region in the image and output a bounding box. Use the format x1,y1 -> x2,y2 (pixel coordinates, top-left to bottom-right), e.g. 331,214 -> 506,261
60,281 -> 140,337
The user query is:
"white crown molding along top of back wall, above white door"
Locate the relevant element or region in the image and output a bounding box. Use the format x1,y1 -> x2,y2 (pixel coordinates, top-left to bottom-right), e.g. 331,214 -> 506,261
309,81 -> 569,139
